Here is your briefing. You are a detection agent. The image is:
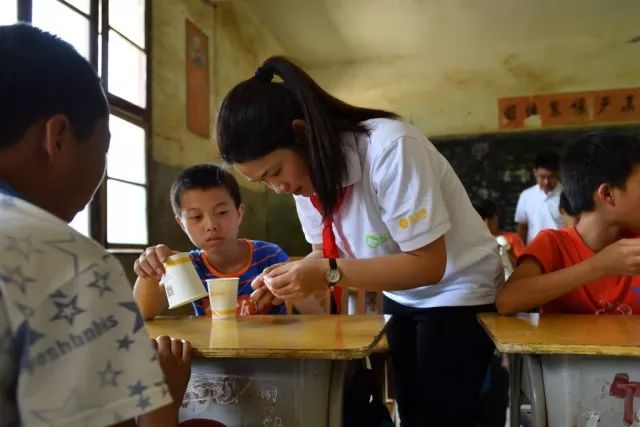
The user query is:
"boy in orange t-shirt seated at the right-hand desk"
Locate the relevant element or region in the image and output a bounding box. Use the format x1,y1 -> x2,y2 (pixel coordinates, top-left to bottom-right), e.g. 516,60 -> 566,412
496,132 -> 640,314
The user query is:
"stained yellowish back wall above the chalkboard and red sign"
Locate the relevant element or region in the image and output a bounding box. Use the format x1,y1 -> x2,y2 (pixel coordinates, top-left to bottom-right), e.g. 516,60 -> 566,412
308,42 -> 640,136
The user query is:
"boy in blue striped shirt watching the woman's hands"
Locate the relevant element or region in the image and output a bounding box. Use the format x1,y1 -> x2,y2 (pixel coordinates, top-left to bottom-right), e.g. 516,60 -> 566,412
133,164 -> 321,319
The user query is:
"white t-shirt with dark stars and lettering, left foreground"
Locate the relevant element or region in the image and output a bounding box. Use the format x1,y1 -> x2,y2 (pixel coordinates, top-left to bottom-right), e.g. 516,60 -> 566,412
0,194 -> 171,427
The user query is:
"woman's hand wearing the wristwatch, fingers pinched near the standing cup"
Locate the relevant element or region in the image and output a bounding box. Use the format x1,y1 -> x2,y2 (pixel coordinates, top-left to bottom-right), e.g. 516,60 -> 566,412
261,259 -> 328,301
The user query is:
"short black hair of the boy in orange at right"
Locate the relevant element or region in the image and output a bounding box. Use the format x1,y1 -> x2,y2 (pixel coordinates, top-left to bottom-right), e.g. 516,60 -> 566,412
560,131 -> 640,215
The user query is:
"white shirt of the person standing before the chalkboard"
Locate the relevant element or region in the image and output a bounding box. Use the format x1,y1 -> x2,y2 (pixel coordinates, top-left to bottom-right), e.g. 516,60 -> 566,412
515,184 -> 562,244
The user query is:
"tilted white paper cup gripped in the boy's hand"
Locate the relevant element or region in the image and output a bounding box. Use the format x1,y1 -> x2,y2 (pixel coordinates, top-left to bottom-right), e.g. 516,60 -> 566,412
161,253 -> 207,308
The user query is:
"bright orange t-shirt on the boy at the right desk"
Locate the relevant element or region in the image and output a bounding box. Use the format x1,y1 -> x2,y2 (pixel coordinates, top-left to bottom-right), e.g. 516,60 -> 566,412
518,227 -> 640,314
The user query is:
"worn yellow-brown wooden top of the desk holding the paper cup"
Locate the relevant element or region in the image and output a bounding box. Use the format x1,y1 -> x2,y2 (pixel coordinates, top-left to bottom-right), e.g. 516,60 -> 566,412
147,315 -> 386,360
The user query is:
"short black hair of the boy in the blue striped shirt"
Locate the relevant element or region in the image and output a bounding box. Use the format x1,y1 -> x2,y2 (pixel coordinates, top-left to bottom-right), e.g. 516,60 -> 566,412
170,164 -> 242,216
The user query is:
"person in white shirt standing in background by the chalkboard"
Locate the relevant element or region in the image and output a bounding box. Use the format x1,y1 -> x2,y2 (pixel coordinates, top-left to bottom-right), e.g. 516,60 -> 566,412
515,151 -> 563,244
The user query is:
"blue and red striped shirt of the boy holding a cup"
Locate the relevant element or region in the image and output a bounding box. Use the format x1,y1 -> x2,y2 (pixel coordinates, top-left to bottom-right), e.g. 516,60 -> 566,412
189,240 -> 289,316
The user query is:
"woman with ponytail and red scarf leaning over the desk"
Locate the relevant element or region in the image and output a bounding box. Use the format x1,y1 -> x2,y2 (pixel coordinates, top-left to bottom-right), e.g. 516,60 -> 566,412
212,57 -> 503,426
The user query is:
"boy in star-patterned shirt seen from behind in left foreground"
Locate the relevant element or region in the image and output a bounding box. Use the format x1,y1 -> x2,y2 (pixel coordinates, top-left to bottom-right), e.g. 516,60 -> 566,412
0,24 -> 191,427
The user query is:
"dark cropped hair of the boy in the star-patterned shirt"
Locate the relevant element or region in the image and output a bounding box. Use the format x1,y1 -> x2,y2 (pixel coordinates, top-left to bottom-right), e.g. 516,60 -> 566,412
0,23 -> 109,149
